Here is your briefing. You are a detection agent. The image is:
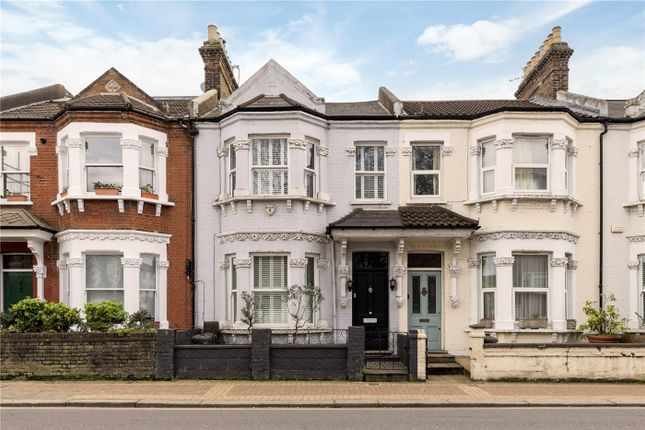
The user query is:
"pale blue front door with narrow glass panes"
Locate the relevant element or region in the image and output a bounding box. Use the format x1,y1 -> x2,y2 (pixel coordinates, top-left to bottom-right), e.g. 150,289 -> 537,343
408,271 -> 441,351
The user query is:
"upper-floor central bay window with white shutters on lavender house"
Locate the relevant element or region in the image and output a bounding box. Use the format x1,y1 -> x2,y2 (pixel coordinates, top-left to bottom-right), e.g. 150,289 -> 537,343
251,139 -> 289,195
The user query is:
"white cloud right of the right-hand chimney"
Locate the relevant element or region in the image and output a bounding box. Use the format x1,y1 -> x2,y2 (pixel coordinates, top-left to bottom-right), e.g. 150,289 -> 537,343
569,46 -> 645,99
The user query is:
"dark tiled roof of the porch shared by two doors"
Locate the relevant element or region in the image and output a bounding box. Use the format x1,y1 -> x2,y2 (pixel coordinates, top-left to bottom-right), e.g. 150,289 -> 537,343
329,205 -> 479,230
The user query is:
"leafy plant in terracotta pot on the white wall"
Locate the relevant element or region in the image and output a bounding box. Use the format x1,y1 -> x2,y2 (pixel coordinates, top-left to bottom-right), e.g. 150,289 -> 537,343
580,294 -> 629,343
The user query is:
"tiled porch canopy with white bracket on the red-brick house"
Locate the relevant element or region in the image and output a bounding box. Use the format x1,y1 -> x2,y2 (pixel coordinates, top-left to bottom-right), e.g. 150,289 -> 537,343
0,207 -> 56,299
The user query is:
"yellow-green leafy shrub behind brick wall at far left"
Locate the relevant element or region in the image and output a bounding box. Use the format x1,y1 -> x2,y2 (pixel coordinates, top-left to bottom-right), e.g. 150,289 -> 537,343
2,297 -> 81,333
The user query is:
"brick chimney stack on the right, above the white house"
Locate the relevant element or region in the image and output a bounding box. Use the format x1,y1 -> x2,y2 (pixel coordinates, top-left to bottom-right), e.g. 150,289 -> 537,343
515,27 -> 573,100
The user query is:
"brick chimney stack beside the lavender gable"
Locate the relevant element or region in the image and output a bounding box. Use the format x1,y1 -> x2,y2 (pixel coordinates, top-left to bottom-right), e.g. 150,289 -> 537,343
199,24 -> 237,99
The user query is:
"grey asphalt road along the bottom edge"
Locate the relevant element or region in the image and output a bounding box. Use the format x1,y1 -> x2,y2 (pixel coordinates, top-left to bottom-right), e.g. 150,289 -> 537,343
0,407 -> 645,430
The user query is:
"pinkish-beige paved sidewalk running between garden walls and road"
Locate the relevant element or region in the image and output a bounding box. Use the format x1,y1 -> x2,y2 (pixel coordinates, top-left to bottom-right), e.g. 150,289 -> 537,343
0,375 -> 645,408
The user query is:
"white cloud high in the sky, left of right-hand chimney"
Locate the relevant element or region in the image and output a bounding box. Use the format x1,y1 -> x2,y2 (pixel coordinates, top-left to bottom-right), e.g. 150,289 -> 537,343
417,1 -> 589,63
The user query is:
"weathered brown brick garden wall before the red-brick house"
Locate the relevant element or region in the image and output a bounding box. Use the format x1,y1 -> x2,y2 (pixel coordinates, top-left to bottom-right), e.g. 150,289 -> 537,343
0,333 -> 156,379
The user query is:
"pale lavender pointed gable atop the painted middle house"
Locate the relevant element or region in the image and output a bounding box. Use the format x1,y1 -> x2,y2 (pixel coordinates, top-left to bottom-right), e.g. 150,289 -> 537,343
221,60 -> 325,113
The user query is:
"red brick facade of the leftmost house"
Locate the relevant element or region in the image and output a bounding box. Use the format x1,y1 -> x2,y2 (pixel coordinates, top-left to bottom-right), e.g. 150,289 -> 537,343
0,77 -> 193,327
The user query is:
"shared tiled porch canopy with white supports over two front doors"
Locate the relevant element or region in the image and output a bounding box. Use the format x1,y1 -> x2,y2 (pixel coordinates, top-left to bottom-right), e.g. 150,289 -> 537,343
327,204 -> 479,346
